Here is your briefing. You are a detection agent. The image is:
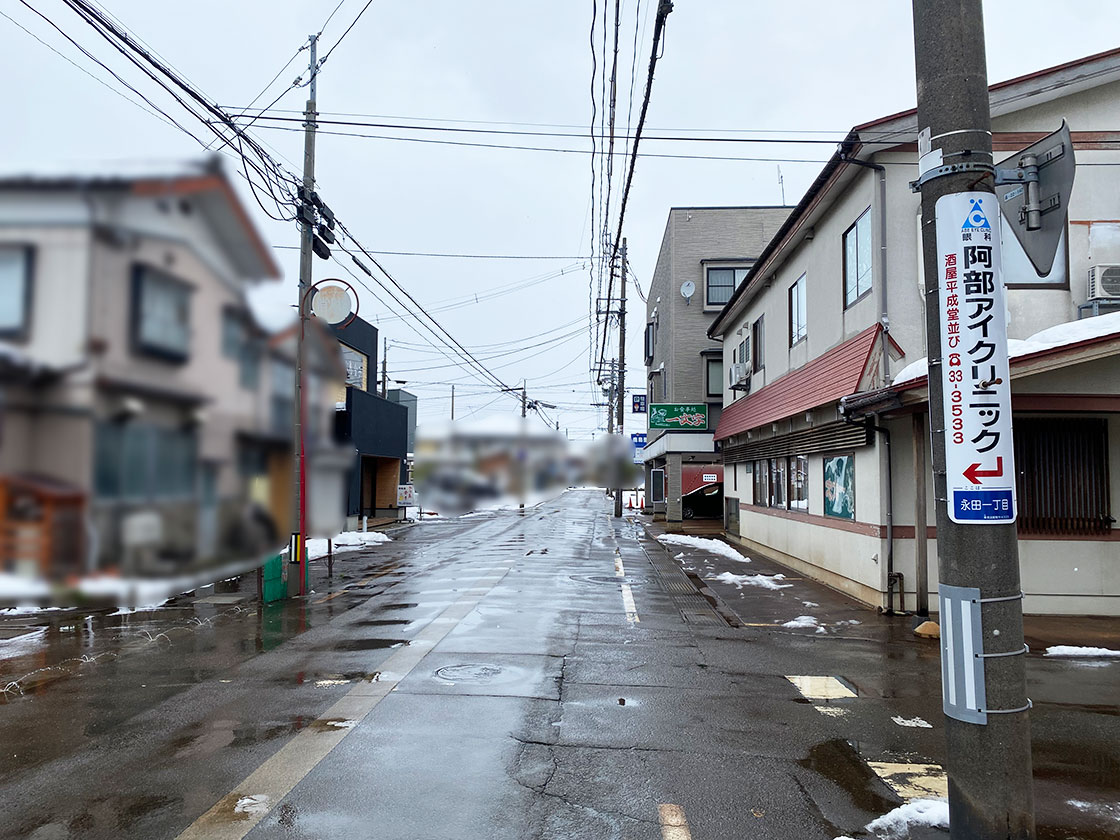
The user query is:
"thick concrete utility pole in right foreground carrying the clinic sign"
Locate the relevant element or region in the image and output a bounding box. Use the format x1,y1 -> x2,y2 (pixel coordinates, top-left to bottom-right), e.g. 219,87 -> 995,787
914,0 -> 1035,840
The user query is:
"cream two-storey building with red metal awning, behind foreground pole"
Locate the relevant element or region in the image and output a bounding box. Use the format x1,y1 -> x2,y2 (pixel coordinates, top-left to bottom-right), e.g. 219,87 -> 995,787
708,50 -> 1120,615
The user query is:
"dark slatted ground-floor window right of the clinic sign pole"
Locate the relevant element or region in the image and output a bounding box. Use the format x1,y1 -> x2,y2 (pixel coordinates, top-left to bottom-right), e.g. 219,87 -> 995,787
1015,417 -> 1113,535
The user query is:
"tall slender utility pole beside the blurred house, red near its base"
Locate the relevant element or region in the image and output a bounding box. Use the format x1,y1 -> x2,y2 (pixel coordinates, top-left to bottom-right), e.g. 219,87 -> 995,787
288,35 -> 319,595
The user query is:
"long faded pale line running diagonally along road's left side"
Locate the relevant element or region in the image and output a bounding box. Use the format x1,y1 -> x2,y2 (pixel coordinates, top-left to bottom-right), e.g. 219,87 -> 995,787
177,563 -> 510,840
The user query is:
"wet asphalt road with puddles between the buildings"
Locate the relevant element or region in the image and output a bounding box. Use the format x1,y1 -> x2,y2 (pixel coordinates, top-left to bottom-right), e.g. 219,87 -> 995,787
0,491 -> 1120,840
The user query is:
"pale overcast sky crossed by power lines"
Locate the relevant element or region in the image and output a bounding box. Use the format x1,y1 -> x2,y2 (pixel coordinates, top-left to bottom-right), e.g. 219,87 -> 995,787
0,0 -> 1120,438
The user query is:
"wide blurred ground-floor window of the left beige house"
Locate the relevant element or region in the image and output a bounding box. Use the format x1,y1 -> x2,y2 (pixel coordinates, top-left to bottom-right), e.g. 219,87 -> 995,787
94,422 -> 197,501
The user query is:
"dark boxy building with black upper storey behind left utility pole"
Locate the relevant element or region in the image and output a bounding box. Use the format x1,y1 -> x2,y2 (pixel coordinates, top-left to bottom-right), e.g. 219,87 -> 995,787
333,317 -> 416,530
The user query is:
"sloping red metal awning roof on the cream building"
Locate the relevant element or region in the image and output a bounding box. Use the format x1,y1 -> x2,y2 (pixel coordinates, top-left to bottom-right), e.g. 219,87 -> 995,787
716,324 -> 900,440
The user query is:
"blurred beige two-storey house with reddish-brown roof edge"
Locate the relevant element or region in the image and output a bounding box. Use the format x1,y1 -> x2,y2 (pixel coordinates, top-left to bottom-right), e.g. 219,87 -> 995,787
0,157 -> 342,572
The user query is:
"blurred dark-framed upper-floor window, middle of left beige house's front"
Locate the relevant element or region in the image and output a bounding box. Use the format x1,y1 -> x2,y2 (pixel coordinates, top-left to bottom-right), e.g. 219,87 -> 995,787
132,265 -> 190,362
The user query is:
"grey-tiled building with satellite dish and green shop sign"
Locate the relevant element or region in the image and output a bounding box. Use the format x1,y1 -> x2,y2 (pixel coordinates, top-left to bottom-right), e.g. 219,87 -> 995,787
642,206 -> 790,522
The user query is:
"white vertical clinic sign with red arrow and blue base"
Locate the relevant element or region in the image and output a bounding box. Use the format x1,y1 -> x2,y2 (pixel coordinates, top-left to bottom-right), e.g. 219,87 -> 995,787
936,193 -> 1016,524
